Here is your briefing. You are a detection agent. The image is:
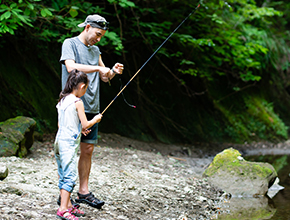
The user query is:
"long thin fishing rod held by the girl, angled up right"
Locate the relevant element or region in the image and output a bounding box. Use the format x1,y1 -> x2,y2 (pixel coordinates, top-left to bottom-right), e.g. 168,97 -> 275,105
102,4 -> 200,115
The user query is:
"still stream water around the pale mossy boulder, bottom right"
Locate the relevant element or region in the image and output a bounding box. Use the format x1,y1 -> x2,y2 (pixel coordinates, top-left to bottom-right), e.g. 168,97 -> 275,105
219,155 -> 290,220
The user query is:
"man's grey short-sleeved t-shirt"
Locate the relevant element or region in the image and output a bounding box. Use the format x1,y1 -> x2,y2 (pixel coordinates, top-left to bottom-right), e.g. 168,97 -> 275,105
60,37 -> 101,114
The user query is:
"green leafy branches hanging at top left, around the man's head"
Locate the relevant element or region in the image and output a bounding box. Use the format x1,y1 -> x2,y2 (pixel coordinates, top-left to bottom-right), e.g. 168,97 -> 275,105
0,0 -> 125,55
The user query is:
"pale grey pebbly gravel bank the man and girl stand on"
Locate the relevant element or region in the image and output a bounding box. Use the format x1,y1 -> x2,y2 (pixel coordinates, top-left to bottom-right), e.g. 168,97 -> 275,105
0,131 -> 232,220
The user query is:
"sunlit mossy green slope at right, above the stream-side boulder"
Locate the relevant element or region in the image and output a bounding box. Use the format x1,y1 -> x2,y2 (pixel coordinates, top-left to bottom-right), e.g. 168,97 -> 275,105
215,96 -> 288,141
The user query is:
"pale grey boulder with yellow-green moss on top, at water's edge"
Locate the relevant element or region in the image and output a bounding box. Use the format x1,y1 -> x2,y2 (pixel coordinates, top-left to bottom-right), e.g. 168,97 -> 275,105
203,148 -> 277,197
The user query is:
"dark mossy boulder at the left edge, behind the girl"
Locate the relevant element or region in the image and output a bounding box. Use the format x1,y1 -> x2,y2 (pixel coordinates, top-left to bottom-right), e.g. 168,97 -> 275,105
0,116 -> 36,157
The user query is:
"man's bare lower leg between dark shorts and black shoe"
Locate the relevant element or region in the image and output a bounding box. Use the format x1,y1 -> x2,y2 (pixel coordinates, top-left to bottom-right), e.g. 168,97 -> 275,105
78,142 -> 94,195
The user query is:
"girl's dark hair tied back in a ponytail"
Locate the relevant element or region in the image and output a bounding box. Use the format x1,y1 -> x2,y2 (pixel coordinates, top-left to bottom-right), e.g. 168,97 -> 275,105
58,69 -> 89,101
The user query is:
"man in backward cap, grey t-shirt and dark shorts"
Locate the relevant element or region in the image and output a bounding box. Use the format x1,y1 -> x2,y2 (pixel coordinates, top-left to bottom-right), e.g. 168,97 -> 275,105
58,14 -> 123,208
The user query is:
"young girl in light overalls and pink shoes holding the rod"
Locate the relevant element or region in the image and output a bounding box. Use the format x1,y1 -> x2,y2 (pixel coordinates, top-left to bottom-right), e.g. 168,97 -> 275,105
54,70 -> 102,220
